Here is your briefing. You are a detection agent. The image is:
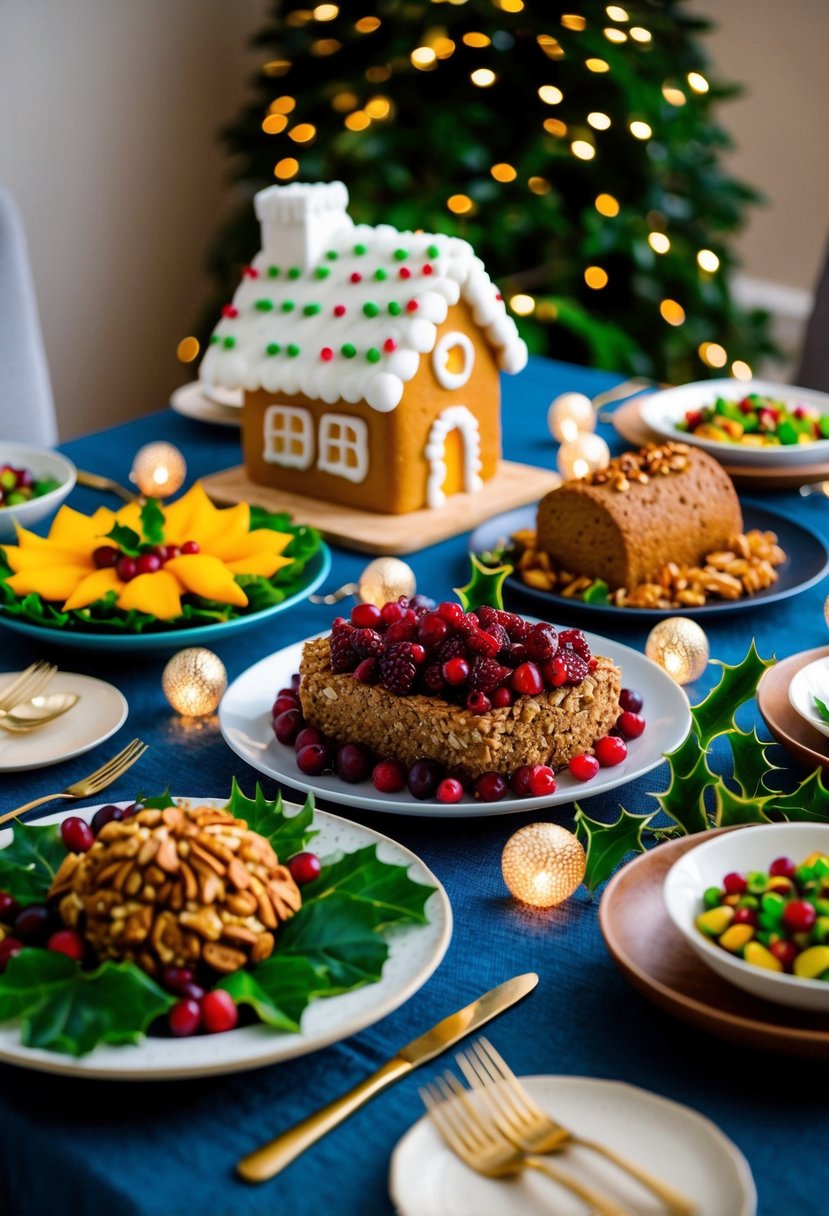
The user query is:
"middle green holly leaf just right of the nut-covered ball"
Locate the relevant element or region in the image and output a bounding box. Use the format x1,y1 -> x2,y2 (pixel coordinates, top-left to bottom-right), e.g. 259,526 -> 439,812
277,893 -> 389,996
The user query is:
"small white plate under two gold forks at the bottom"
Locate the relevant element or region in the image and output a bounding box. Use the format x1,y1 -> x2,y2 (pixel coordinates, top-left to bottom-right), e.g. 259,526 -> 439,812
389,1076 -> 757,1216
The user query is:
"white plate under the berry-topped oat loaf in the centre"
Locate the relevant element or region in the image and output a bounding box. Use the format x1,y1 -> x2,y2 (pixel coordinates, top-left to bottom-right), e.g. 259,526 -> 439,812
219,617 -> 690,817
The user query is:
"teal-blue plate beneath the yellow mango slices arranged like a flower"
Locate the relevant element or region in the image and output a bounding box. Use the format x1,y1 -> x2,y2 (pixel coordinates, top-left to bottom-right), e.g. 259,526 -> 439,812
0,544 -> 331,651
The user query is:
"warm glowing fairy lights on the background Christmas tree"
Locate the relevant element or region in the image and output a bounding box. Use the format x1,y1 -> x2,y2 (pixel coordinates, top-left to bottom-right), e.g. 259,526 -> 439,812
177,0 -> 754,381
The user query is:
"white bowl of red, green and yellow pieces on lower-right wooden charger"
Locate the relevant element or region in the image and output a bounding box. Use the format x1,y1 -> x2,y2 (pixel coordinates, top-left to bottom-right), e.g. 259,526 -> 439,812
662,823 -> 829,1013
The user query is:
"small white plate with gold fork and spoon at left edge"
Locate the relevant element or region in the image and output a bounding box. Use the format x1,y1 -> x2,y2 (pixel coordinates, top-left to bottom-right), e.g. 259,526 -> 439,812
0,671 -> 129,772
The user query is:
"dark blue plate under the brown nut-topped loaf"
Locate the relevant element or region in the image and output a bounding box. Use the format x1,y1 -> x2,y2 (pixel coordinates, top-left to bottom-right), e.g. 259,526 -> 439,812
469,502 -> 829,623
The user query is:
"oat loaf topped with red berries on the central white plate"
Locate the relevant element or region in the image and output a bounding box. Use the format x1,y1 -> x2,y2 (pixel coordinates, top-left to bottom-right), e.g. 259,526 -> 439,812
299,596 -> 620,778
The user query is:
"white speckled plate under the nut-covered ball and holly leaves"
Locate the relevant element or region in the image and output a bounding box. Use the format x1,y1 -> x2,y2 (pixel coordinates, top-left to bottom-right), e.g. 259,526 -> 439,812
0,796 -> 452,1081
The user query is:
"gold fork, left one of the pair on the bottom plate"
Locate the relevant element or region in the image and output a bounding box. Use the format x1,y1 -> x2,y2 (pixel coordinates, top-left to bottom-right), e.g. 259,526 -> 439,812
419,1071 -> 630,1216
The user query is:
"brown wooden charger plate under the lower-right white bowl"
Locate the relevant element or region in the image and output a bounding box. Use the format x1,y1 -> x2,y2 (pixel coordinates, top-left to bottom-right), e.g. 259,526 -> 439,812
599,828 -> 829,1059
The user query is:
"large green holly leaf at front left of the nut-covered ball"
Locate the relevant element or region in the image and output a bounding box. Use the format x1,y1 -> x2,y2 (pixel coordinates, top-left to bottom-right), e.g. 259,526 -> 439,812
0,948 -> 175,1055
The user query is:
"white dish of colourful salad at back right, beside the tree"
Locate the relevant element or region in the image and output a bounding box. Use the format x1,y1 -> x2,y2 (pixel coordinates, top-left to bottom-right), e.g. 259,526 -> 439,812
641,378 -> 829,468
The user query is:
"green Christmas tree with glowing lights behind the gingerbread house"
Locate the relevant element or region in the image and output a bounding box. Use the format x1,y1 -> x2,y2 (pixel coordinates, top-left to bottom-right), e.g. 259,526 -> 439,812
192,0 -> 771,383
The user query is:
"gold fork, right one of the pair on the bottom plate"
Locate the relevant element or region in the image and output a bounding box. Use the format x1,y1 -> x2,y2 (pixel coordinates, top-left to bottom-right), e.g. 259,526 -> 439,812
456,1036 -> 697,1216
